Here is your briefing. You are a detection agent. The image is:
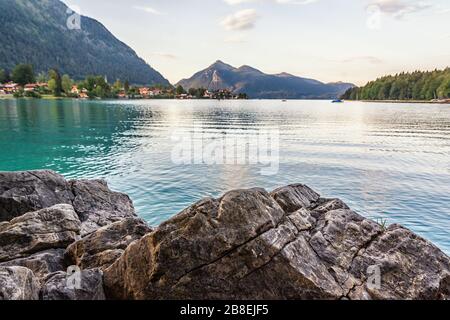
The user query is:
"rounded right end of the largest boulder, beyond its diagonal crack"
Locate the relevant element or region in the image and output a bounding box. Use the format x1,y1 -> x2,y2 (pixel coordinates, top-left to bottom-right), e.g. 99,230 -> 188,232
349,225 -> 450,300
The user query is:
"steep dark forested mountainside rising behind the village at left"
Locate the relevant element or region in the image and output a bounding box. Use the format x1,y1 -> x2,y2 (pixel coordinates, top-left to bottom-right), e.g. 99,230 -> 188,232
0,0 -> 169,85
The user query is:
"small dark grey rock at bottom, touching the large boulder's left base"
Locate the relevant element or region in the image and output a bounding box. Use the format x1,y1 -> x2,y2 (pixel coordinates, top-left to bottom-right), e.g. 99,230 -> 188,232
40,269 -> 105,300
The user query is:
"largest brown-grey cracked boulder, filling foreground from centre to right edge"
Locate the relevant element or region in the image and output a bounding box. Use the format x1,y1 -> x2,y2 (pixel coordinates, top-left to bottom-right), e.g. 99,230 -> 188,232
104,185 -> 450,299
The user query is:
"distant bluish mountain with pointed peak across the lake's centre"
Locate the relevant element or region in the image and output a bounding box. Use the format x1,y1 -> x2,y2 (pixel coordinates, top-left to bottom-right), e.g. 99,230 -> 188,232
178,61 -> 354,99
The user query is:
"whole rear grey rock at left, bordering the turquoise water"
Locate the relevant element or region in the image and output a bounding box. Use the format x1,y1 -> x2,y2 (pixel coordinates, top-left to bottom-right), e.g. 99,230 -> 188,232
0,171 -> 136,235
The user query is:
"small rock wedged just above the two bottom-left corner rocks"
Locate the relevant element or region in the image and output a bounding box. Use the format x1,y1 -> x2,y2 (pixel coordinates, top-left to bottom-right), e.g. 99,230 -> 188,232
0,249 -> 66,281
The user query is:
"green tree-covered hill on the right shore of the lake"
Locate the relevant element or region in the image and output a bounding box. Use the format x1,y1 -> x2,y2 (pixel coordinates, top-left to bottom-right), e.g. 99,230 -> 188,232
342,68 -> 450,100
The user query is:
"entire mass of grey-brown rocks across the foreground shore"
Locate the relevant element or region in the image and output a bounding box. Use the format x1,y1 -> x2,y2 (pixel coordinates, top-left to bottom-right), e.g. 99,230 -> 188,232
0,171 -> 450,300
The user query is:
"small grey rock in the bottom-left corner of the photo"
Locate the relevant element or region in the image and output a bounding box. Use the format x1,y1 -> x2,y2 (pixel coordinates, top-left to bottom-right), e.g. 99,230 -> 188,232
0,267 -> 39,300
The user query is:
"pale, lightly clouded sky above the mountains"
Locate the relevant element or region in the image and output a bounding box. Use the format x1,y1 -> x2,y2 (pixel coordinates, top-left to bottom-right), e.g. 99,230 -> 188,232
64,0 -> 450,85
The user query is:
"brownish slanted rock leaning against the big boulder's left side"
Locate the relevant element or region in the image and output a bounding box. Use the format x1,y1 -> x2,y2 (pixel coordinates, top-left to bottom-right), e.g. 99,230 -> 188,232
65,218 -> 152,269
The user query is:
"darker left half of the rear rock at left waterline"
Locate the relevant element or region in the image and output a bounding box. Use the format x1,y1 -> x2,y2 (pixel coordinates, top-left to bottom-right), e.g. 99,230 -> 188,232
0,171 -> 73,222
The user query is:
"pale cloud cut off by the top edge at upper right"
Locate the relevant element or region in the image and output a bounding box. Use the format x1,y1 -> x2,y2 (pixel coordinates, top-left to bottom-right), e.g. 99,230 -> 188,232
369,0 -> 432,18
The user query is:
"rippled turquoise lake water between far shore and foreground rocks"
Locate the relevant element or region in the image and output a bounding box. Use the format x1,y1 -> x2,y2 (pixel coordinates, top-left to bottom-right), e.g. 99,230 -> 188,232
0,100 -> 450,253
